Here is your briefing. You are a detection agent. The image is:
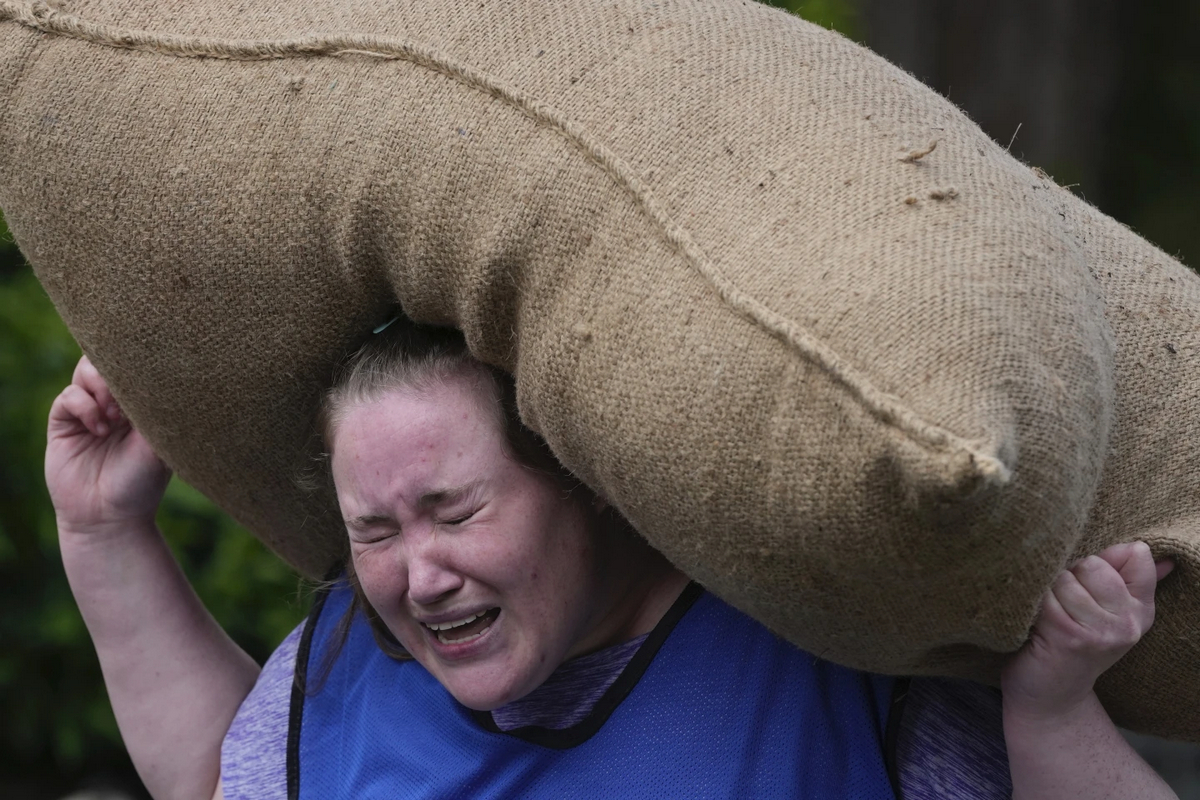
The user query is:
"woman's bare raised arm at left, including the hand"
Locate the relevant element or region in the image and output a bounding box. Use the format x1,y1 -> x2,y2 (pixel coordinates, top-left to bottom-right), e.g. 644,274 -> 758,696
46,356 -> 258,800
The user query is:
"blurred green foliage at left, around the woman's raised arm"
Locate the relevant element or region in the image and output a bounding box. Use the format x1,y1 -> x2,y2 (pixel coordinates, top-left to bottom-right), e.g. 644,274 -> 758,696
0,211 -> 305,794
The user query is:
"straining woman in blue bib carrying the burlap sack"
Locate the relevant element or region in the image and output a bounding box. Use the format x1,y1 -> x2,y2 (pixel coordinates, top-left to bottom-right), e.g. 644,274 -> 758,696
47,325 -> 1174,798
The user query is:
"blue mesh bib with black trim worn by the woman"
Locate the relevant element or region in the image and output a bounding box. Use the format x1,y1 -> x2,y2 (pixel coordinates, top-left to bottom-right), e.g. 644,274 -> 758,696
288,584 -> 895,800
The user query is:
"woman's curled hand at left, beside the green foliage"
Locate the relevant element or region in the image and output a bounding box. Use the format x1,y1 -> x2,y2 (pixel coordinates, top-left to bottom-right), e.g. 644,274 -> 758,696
46,356 -> 170,535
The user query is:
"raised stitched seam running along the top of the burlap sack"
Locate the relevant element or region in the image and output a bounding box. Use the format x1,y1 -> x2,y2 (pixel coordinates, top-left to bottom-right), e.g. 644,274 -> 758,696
0,0 -> 1010,483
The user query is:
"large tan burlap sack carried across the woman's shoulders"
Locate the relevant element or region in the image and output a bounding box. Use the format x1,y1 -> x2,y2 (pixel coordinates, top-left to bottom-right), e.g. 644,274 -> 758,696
0,0 -> 1200,739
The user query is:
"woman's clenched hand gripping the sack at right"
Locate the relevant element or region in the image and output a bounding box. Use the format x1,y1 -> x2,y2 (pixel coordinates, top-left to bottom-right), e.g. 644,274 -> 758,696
1001,542 -> 1174,718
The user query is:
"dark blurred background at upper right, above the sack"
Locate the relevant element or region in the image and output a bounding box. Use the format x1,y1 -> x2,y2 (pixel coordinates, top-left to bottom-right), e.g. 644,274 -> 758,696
854,0 -> 1200,269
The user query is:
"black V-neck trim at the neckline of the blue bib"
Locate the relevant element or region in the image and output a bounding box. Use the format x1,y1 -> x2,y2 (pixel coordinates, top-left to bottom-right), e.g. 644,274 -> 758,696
470,582 -> 704,750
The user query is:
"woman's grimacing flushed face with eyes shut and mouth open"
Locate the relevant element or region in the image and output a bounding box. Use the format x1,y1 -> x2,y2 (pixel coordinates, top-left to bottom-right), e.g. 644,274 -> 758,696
331,371 -> 607,710
